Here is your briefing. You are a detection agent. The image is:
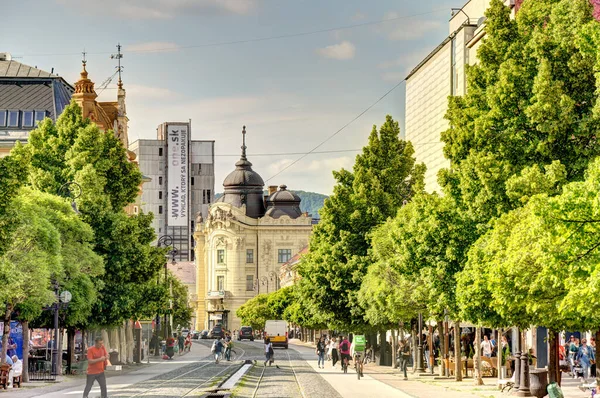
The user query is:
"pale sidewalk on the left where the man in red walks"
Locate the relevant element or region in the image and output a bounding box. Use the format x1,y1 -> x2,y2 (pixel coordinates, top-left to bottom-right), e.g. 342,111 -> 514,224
0,344 -> 210,398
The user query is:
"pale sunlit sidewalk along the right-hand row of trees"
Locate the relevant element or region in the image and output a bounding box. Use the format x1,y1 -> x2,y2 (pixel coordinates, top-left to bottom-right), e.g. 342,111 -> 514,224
290,340 -> 591,398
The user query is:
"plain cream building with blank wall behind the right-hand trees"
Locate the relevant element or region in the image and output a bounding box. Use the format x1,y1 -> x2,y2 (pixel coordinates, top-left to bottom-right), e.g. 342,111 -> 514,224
405,0 -> 522,192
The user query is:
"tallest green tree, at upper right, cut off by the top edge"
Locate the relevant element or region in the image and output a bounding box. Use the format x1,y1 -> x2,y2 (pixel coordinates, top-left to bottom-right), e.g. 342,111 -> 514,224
440,0 -> 600,224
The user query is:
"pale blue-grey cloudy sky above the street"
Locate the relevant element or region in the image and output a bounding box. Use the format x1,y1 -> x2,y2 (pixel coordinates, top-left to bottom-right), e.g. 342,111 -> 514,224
0,0 -> 454,194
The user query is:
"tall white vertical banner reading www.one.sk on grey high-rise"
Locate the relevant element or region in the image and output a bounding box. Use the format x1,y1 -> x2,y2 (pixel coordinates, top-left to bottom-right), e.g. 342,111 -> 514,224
167,124 -> 189,227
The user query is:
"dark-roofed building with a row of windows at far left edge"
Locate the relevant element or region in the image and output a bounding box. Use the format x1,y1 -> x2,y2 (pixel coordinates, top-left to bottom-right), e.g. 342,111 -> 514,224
0,53 -> 75,156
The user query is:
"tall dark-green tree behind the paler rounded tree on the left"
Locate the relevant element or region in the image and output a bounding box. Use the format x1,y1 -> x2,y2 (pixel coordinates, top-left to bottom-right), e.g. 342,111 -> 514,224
13,103 -> 167,326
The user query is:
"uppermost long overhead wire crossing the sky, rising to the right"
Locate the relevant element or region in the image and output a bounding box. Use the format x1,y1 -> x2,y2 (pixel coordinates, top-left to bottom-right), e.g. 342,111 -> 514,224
16,7 -> 448,57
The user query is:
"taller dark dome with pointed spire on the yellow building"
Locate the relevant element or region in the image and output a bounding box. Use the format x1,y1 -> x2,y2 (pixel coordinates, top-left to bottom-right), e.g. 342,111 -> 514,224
217,126 -> 265,218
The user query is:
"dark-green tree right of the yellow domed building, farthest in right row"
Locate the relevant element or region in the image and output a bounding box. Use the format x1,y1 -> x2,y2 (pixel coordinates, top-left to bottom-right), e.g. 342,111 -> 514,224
298,116 -> 424,330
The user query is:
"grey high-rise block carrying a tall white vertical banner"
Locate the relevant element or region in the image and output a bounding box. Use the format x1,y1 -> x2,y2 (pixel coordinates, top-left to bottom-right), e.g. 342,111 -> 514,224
129,122 -> 215,261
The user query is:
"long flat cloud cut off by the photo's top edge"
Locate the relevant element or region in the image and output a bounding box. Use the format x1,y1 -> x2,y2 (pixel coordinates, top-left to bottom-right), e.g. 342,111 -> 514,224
56,0 -> 256,19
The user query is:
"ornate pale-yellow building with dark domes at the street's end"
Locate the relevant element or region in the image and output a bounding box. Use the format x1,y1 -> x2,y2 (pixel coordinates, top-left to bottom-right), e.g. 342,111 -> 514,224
194,128 -> 312,330
